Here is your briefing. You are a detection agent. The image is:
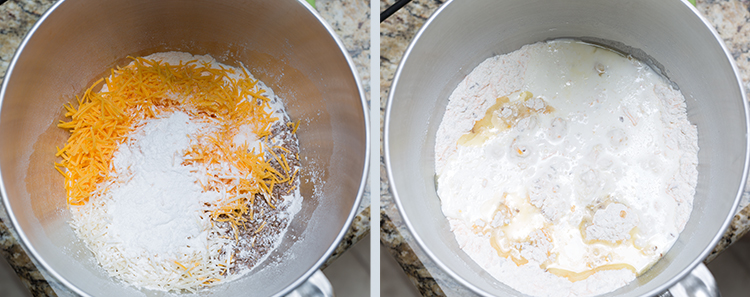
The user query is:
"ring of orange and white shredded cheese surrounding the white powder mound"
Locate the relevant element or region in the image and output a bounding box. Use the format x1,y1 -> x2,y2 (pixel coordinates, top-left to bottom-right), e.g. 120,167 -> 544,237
54,52 -> 301,292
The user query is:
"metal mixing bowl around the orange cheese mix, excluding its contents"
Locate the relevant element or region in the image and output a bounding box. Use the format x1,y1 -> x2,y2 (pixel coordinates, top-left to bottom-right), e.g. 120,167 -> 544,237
0,0 -> 369,296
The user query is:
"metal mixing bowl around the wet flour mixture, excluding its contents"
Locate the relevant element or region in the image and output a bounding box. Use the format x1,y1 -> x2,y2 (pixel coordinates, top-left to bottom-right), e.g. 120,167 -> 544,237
384,0 -> 748,296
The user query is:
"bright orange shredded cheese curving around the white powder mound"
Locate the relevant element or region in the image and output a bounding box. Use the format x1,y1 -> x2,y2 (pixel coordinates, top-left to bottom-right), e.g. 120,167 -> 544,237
54,57 -> 299,236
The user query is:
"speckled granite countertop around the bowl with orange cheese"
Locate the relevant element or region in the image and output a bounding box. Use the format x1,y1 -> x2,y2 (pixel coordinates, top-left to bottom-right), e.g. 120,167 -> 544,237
0,0 -> 370,296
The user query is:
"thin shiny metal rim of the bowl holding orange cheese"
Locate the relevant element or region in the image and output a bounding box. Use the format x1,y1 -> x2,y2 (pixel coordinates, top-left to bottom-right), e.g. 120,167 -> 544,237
0,0 -> 371,296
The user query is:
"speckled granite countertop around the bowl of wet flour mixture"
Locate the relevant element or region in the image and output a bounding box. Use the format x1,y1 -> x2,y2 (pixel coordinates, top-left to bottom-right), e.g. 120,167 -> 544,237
380,0 -> 750,296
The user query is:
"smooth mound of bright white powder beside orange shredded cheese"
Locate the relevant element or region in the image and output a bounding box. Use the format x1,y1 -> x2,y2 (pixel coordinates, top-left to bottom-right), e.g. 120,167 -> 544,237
107,111 -> 221,258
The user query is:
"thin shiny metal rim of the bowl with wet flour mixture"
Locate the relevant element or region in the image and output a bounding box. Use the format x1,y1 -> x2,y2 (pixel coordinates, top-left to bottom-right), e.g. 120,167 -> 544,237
383,0 -> 750,296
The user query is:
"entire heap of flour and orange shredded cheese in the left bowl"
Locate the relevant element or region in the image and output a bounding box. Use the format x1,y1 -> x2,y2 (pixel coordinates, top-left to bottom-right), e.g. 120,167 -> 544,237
62,52 -> 302,292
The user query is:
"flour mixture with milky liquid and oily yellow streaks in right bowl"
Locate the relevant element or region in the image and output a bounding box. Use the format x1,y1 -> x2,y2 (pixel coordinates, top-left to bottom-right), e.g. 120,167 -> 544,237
435,40 -> 698,296
